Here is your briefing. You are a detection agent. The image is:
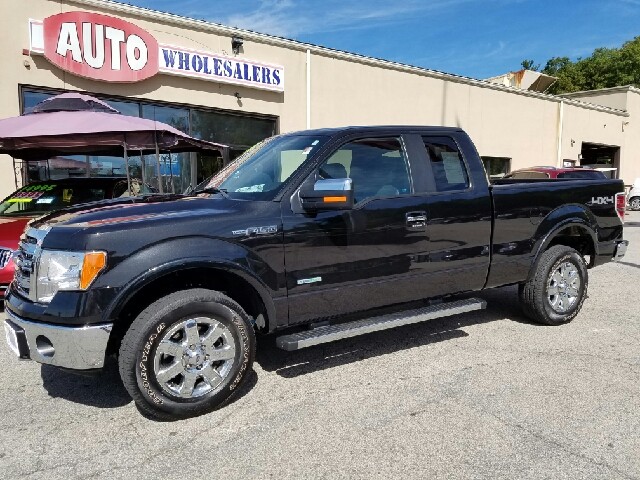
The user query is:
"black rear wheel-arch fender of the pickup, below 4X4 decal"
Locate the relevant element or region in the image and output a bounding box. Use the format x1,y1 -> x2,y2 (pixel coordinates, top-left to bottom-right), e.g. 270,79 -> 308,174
529,204 -> 598,278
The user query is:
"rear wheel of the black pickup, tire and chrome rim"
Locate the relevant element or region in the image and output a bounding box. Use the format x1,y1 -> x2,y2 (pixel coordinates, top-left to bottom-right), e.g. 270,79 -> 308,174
519,245 -> 589,325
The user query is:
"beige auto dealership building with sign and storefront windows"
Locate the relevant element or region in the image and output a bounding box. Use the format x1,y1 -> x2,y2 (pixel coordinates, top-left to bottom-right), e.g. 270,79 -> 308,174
0,0 -> 640,196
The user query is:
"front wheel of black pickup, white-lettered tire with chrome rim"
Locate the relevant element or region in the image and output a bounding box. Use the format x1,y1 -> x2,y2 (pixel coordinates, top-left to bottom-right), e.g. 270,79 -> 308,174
119,289 -> 256,420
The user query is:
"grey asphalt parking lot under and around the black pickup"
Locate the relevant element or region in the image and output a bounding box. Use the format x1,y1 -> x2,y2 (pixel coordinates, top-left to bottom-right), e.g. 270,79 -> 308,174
0,212 -> 640,479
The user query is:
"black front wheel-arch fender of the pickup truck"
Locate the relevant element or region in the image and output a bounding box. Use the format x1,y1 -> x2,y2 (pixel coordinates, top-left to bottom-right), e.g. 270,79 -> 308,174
95,237 -> 277,325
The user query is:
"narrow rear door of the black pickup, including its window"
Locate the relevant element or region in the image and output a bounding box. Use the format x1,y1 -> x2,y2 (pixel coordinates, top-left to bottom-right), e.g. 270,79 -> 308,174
408,134 -> 492,296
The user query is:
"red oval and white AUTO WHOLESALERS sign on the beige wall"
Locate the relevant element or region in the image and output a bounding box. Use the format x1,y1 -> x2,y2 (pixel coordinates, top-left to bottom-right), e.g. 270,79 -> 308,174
29,12 -> 284,92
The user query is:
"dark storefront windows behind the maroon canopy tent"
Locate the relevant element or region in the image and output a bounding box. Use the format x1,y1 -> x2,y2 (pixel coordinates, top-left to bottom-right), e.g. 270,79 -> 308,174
22,88 -> 276,193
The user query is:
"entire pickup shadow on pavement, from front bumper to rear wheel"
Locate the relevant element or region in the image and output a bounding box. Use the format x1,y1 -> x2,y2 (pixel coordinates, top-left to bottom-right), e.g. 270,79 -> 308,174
36,287 -> 532,408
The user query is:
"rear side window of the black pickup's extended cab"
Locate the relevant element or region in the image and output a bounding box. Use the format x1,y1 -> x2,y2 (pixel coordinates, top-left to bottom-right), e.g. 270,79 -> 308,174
423,137 -> 469,192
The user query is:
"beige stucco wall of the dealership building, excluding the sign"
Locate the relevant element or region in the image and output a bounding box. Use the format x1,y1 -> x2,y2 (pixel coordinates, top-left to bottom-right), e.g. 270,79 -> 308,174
0,0 -> 640,196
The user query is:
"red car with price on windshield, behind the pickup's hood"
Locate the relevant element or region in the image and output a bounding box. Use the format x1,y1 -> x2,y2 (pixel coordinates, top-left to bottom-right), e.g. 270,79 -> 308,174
0,177 -> 150,295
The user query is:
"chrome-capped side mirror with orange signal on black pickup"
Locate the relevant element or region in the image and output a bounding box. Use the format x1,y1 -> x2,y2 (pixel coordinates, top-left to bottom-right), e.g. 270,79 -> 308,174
300,178 -> 353,210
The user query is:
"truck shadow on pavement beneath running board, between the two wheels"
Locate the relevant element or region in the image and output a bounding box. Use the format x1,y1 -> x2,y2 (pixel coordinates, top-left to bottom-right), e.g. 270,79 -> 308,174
256,287 -> 528,378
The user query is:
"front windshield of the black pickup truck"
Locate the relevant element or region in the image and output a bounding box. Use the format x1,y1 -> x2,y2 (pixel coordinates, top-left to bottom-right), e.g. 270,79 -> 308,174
204,135 -> 329,200
